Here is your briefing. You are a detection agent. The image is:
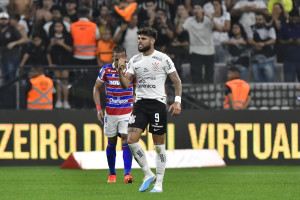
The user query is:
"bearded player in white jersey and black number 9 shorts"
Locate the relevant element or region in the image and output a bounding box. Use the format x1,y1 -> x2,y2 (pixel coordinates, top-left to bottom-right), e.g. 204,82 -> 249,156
118,27 -> 182,193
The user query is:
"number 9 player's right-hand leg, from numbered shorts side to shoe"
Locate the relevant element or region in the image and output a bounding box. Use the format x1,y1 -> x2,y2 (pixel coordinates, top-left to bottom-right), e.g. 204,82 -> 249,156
149,101 -> 167,192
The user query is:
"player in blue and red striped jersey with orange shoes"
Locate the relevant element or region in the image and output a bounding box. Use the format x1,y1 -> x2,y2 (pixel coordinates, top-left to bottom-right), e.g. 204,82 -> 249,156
93,46 -> 134,183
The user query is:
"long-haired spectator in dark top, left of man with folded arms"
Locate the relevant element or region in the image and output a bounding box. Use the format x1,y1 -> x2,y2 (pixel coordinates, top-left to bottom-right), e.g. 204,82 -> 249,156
222,23 -> 250,80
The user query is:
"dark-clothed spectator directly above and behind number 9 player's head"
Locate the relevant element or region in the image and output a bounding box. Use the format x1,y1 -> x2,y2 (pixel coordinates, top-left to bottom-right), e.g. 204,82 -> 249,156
152,9 -> 174,52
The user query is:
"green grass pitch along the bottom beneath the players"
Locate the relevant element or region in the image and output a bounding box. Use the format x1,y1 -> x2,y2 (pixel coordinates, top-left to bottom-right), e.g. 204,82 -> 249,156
0,166 -> 300,200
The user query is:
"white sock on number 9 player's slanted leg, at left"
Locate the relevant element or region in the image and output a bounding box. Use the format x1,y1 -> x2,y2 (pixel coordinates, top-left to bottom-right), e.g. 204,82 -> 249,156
128,142 -> 154,177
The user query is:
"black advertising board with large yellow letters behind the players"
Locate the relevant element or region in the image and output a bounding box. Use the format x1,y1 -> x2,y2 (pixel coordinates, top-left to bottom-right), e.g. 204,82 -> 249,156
0,110 -> 300,166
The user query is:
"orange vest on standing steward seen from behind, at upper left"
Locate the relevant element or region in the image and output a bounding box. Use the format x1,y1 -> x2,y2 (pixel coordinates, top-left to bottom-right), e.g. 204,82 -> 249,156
71,21 -> 97,56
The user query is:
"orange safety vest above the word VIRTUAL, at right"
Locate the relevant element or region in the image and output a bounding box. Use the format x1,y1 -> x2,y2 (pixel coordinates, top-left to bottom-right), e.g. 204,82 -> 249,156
224,79 -> 250,110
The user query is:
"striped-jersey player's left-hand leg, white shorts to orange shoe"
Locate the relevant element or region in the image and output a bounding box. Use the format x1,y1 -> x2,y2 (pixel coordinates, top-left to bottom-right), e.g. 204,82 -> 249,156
104,113 -> 118,183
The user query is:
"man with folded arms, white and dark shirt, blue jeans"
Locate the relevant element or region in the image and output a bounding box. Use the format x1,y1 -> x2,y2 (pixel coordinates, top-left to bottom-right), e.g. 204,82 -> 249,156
247,13 -> 276,82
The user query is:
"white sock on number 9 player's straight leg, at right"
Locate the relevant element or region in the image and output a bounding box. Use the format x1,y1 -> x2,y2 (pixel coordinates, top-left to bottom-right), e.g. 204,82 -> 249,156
154,144 -> 167,190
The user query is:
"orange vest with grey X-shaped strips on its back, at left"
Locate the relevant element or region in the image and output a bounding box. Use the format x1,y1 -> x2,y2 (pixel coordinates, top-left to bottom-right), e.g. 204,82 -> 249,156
27,74 -> 53,109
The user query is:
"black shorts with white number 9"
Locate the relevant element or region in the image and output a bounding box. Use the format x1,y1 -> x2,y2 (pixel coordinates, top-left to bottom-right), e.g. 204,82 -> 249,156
128,99 -> 167,135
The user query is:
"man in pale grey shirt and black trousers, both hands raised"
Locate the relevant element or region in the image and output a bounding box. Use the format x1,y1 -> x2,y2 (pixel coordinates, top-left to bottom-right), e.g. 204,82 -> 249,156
176,5 -> 221,83
